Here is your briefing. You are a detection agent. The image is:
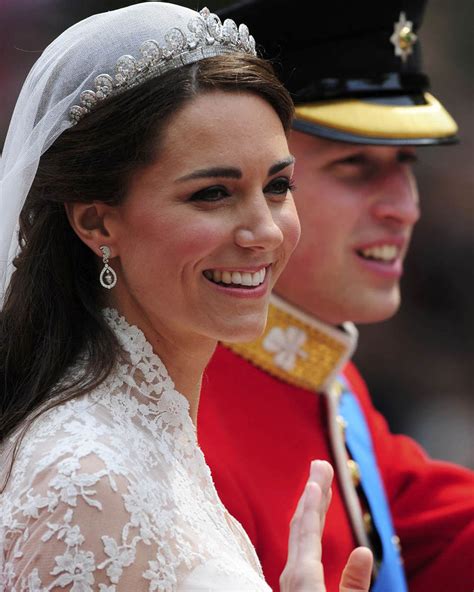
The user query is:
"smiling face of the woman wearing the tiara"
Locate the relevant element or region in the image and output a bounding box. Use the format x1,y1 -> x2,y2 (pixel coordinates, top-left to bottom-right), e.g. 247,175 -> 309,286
108,91 -> 300,343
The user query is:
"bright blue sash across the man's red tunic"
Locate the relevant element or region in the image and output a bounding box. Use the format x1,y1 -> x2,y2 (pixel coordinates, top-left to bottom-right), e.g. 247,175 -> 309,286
338,376 -> 408,592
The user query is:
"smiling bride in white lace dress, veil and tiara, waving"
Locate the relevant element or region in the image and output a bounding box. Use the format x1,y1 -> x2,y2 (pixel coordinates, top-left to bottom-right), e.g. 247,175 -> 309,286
0,2 -> 371,592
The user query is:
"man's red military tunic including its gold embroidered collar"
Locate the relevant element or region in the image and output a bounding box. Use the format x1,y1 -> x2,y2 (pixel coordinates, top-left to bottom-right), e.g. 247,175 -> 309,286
199,299 -> 474,592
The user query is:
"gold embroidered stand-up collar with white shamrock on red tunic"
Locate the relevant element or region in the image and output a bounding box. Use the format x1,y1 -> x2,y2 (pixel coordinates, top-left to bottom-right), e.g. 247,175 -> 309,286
226,294 -> 357,392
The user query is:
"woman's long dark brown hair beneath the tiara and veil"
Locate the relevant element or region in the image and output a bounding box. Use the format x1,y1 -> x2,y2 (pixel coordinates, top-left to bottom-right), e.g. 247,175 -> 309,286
0,54 -> 293,458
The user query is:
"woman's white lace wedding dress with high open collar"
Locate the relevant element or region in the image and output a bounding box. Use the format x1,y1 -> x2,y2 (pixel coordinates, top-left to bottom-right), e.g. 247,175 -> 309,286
0,309 -> 270,592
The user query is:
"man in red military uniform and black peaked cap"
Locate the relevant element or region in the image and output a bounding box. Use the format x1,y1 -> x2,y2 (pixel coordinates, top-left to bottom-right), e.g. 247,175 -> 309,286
199,0 -> 474,592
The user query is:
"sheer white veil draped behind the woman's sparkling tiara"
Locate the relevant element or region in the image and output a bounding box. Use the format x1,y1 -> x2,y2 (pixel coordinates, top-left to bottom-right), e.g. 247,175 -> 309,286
0,2 -> 252,306
